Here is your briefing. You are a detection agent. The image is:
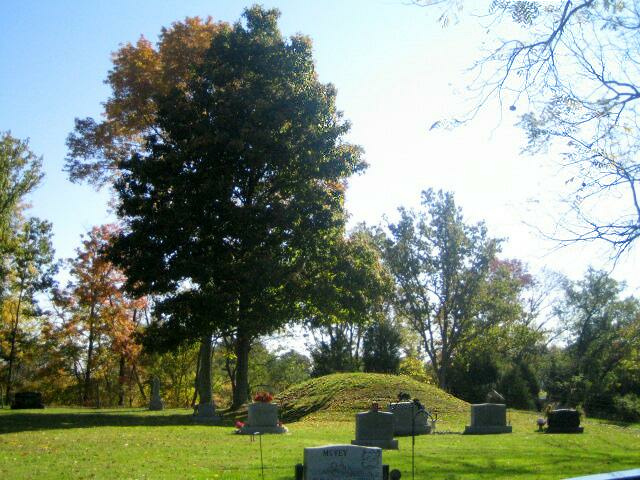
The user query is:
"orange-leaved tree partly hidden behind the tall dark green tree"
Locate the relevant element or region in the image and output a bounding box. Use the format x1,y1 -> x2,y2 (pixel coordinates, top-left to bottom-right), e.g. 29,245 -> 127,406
65,17 -> 222,408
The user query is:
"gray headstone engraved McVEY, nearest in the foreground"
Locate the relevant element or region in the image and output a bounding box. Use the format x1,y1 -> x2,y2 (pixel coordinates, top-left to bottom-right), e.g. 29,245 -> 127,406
304,445 -> 382,480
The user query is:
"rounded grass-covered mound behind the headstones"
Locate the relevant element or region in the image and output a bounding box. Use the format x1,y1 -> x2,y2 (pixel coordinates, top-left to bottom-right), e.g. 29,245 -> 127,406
276,373 -> 469,422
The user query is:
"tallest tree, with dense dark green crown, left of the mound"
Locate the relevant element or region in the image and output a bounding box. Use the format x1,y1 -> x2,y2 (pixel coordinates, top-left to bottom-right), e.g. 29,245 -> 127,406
113,7 -> 364,406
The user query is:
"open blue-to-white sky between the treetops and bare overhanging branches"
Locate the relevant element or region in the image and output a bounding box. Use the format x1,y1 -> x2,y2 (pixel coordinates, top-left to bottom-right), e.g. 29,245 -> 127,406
0,0 -> 640,293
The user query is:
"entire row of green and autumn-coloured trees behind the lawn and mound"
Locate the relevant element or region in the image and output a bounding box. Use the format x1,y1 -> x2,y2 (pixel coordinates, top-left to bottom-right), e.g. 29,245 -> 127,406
0,7 -> 640,419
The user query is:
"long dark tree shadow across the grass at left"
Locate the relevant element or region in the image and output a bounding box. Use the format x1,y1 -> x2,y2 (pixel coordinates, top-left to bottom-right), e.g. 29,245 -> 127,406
0,411 -> 232,435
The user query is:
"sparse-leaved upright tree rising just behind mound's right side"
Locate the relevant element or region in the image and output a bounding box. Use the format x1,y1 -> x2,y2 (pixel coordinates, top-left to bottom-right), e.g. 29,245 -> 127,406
382,190 -> 498,388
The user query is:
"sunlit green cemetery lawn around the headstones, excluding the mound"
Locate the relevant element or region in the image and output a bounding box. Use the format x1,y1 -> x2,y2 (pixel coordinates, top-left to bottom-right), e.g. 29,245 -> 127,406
0,408 -> 640,480
